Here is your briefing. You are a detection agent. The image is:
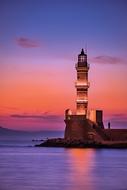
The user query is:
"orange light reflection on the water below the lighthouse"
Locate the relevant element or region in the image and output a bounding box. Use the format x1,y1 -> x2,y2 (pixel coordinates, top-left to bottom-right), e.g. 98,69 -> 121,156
65,149 -> 95,190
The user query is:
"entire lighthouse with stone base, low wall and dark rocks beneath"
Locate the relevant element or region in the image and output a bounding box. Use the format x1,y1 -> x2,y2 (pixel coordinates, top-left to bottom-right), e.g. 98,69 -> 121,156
36,49 -> 127,149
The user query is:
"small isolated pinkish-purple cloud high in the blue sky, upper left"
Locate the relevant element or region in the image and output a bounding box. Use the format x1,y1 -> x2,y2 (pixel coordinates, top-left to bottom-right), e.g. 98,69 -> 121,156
16,37 -> 40,48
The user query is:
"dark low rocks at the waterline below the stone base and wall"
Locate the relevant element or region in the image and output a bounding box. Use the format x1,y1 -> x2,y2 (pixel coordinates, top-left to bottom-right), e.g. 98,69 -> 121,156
35,138 -> 127,149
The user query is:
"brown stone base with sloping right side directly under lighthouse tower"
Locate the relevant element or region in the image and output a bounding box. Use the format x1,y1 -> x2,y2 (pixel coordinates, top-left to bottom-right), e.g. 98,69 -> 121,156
64,115 -> 104,141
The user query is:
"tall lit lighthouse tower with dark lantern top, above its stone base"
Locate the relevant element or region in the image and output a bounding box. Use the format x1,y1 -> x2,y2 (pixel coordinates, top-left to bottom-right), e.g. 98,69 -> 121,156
75,49 -> 89,117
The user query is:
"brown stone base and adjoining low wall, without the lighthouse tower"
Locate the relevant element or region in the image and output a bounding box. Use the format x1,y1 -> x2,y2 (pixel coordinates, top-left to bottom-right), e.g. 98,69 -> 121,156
64,115 -> 127,142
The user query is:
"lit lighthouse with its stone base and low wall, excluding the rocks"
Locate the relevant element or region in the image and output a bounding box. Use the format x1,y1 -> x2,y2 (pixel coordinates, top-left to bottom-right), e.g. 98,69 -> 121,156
64,49 -> 127,142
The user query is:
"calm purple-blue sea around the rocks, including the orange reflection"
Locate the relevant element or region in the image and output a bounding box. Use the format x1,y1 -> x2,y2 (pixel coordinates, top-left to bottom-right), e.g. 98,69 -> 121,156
0,132 -> 127,190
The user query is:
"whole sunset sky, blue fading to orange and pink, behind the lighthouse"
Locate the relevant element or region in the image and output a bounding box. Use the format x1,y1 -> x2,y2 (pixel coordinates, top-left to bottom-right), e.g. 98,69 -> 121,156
0,0 -> 127,130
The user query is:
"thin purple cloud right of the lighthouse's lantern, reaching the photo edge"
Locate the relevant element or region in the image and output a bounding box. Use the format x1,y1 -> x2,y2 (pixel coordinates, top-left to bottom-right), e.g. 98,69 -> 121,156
93,55 -> 127,64
